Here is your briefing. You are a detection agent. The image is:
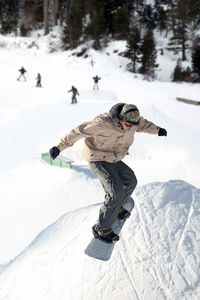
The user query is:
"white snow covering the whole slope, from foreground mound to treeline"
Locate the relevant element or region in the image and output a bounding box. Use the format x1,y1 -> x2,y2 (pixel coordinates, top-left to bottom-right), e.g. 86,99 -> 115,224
0,31 -> 200,300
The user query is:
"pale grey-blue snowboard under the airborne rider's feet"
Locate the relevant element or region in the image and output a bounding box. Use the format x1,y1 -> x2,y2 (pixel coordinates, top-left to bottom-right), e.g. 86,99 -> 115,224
84,198 -> 134,261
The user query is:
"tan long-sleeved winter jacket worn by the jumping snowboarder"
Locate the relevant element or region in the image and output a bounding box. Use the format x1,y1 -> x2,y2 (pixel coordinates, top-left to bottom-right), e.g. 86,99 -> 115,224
57,113 -> 160,163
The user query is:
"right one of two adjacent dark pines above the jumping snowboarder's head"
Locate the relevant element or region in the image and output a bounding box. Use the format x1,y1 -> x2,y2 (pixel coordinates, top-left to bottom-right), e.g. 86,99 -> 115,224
140,29 -> 159,78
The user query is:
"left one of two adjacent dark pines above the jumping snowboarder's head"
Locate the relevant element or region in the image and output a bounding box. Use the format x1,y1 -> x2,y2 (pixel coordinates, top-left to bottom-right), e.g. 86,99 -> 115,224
125,25 -> 141,73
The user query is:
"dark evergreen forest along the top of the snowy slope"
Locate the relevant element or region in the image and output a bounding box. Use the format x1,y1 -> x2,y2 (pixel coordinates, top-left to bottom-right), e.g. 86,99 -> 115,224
0,0 -> 200,82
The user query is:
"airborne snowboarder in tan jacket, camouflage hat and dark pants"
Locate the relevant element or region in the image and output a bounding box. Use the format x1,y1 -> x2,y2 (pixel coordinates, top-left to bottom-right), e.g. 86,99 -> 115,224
49,103 -> 167,243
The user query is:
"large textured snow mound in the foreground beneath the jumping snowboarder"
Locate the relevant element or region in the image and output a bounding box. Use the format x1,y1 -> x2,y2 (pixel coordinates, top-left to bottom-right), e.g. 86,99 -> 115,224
0,180 -> 200,300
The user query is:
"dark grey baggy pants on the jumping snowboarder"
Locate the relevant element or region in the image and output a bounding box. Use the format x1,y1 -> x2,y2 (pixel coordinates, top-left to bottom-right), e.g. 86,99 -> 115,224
89,161 -> 137,230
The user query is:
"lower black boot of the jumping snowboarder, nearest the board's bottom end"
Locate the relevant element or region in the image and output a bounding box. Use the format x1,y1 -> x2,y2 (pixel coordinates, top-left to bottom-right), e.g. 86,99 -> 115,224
92,225 -> 119,244
